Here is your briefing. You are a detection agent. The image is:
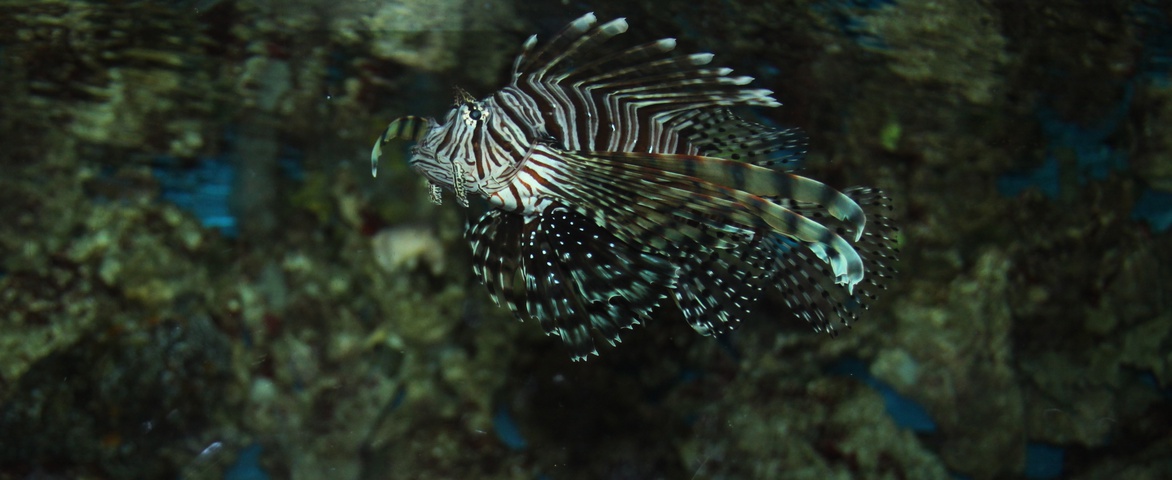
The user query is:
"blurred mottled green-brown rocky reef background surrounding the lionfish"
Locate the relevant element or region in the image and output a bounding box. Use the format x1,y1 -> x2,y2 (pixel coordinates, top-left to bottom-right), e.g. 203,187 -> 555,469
0,0 -> 1172,480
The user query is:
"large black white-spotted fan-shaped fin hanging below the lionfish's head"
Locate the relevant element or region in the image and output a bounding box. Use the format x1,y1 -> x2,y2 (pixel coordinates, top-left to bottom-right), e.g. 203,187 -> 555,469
469,206 -> 676,361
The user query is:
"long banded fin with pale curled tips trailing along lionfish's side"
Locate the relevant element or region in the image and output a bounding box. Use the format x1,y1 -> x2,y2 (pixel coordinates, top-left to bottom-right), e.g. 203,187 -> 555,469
557,152 -> 866,290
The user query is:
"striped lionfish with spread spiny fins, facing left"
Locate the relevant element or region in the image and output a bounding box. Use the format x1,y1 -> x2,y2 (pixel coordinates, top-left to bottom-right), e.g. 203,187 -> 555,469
370,14 -> 895,361
